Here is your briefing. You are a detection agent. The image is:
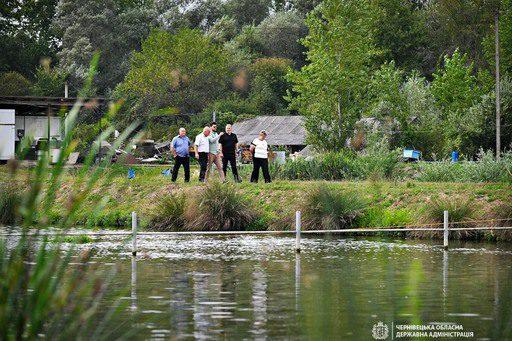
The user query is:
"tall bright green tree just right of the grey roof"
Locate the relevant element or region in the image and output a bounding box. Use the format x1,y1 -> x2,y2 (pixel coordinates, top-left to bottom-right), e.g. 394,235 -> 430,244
290,0 -> 377,149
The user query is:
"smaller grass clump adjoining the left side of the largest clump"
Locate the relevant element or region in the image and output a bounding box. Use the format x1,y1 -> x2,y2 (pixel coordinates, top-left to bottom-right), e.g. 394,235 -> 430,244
148,193 -> 186,231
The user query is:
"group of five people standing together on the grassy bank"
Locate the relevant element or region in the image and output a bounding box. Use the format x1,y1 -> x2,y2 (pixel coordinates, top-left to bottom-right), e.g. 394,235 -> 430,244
171,122 -> 271,182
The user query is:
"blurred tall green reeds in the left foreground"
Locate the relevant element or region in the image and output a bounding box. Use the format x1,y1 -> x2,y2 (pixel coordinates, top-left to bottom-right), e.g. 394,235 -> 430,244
0,55 -> 140,340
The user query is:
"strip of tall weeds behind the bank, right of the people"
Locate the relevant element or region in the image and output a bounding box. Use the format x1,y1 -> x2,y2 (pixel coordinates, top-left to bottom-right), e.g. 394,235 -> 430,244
273,150 -> 512,183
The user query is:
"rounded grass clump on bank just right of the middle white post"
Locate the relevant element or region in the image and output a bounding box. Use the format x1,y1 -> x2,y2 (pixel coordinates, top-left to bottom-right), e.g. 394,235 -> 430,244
303,184 -> 367,230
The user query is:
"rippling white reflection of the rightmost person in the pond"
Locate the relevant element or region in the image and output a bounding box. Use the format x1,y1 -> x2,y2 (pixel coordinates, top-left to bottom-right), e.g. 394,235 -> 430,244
251,265 -> 267,338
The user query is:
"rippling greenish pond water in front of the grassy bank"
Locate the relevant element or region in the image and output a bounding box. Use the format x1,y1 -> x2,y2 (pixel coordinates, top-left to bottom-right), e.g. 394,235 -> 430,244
8,231 -> 512,340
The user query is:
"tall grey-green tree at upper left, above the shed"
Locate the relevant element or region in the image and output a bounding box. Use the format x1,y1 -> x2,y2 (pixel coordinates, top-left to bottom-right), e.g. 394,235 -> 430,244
53,0 -> 156,95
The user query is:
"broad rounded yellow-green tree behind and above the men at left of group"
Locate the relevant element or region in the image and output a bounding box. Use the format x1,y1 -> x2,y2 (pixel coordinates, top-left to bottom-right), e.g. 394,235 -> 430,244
115,29 -> 233,130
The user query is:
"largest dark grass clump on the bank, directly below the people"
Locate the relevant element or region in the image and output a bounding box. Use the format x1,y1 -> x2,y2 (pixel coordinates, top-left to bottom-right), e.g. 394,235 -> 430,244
186,181 -> 259,231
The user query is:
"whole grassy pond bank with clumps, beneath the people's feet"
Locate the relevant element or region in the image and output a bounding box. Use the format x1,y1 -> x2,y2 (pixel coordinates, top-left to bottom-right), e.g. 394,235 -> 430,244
0,166 -> 512,239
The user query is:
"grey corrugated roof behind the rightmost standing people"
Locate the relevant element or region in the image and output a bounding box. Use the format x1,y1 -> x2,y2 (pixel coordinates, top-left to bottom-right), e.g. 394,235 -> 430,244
233,116 -> 306,146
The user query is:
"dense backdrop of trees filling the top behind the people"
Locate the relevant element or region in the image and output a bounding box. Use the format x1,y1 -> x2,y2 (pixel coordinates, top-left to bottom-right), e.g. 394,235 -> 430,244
0,0 -> 512,159
